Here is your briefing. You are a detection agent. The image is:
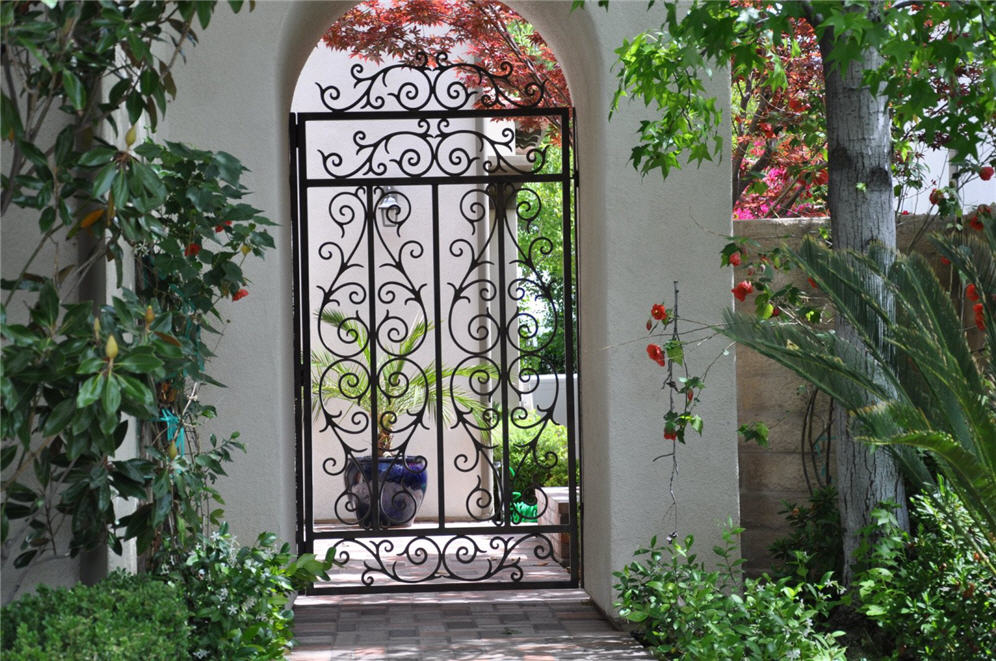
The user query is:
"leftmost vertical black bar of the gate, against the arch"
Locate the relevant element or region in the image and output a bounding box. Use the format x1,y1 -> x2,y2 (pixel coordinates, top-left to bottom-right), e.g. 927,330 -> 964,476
287,113 -> 311,554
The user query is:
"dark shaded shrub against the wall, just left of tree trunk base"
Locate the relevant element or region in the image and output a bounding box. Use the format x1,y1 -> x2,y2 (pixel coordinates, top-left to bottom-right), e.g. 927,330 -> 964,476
769,486 -> 844,581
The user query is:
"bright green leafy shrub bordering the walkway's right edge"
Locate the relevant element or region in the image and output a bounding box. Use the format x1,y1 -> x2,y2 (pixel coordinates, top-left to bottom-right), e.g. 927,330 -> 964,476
615,527 -> 844,661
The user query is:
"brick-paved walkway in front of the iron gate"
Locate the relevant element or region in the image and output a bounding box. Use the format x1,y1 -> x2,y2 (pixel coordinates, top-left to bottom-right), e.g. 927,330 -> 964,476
289,590 -> 653,661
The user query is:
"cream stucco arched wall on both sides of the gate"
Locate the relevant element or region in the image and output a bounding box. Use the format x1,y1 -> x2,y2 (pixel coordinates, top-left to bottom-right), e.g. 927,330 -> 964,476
146,0 -> 738,610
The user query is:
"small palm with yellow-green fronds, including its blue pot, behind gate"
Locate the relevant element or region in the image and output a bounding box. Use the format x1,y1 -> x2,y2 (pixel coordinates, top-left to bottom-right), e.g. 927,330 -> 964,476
311,309 -> 497,528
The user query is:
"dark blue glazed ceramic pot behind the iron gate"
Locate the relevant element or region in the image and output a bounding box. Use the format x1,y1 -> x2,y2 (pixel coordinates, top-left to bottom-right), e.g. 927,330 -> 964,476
343,455 -> 429,528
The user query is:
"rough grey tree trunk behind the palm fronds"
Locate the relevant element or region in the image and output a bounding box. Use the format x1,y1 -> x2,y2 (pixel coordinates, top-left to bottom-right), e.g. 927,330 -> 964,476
820,6 -> 908,584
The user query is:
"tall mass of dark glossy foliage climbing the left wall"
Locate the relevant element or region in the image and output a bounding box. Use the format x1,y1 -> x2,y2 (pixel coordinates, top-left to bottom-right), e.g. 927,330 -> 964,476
0,2 -> 273,566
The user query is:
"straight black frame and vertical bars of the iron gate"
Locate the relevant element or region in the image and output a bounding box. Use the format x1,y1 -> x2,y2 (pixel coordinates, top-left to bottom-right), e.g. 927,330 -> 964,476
288,54 -> 581,594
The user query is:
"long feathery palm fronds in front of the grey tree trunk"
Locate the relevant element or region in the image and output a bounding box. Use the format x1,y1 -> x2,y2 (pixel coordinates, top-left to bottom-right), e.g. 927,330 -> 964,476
722,210 -> 996,575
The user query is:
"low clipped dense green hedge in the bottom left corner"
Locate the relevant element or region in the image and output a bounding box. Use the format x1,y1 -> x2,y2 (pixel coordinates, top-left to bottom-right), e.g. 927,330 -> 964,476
2,571 -> 188,661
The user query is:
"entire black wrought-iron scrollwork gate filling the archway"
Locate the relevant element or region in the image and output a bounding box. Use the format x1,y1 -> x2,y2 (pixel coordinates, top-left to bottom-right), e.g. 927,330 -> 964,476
290,56 -> 580,592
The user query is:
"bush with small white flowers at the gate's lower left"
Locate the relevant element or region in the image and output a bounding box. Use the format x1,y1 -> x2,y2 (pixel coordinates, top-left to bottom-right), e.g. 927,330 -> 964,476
163,524 -> 330,659
